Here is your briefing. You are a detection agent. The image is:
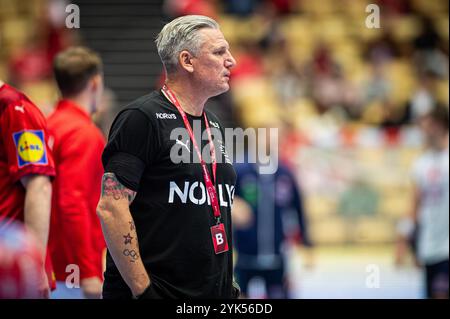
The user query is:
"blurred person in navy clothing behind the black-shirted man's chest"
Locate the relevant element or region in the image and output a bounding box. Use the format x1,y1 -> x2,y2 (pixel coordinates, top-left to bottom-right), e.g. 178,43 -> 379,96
233,125 -> 311,299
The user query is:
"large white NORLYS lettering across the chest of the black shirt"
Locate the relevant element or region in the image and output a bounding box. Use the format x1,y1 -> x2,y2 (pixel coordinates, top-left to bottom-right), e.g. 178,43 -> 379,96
168,181 -> 234,207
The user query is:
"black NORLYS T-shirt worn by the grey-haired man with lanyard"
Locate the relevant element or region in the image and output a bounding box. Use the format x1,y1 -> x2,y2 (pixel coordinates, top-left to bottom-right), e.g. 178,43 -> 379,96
102,91 -> 236,298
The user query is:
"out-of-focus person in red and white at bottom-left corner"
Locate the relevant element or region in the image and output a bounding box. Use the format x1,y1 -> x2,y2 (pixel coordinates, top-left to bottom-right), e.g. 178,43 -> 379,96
0,221 -> 44,299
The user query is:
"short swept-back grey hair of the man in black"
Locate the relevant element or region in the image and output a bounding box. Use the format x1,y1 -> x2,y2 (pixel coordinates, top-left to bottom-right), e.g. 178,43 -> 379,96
155,15 -> 219,73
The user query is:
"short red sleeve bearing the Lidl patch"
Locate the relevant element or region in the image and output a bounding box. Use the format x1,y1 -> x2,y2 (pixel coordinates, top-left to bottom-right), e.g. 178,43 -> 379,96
0,100 -> 55,181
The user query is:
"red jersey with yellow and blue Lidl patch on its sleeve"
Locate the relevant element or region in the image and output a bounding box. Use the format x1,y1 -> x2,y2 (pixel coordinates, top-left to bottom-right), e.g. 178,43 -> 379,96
0,84 -> 55,288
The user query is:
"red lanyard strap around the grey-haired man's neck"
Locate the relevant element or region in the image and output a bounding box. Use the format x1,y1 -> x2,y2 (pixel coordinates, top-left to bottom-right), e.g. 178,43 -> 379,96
162,85 -> 220,223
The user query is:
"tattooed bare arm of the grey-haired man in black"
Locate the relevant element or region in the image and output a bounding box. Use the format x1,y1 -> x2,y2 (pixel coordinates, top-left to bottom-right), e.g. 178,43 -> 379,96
97,173 -> 150,296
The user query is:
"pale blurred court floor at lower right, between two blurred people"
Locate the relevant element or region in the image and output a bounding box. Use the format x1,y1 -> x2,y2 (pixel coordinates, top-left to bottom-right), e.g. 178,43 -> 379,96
289,245 -> 423,299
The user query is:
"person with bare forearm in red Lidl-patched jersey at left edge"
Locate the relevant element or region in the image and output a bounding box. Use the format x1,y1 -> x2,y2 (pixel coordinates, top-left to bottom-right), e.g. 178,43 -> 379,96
0,81 -> 55,298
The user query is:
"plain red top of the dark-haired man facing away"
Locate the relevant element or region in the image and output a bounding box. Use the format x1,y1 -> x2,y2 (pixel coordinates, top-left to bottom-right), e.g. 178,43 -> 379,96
48,100 -> 106,281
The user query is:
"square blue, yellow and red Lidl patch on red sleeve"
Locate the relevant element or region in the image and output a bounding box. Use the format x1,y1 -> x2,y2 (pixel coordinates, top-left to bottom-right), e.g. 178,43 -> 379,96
13,130 -> 48,168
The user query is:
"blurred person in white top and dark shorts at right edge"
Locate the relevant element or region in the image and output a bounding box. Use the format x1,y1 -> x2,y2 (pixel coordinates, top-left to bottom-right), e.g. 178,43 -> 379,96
413,106 -> 449,298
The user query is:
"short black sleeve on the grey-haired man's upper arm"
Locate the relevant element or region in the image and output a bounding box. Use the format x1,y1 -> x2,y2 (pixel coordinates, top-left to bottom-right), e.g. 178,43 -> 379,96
102,109 -> 156,192
